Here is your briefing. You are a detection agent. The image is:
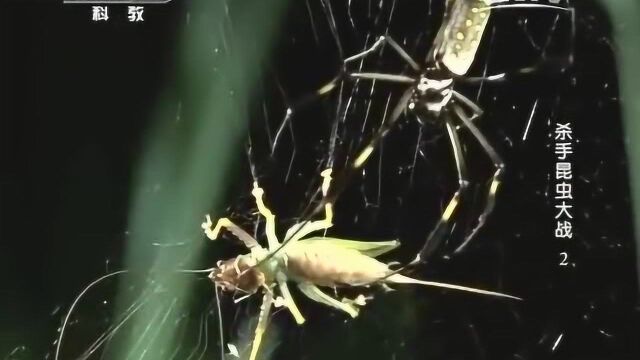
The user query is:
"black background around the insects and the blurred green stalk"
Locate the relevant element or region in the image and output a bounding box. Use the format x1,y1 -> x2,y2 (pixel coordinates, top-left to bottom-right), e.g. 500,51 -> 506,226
0,0 -> 640,359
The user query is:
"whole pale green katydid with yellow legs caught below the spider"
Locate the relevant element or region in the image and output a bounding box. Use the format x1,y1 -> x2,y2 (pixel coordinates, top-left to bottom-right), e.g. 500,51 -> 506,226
202,169 -> 522,360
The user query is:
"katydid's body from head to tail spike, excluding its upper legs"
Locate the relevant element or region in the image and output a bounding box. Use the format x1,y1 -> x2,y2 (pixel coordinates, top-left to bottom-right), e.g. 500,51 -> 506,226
220,237 -> 521,317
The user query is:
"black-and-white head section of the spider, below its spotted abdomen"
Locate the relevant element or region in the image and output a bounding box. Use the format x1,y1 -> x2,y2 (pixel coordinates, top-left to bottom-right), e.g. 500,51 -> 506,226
408,74 -> 453,115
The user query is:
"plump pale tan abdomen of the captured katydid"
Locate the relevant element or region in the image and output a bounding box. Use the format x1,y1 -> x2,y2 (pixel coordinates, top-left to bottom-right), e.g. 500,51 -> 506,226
286,241 -> 389,287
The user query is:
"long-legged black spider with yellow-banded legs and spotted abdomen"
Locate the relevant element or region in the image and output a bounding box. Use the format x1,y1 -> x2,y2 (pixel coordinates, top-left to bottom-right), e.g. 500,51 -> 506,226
290,0 -> 575,266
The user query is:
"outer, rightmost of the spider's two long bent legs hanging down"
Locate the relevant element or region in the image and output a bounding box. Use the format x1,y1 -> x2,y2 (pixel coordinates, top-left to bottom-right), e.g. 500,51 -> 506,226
453,105 -> 505,253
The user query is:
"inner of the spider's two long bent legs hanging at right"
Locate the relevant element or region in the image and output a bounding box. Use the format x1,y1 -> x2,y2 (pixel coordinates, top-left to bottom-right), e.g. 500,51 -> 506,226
409,112 -> 469,265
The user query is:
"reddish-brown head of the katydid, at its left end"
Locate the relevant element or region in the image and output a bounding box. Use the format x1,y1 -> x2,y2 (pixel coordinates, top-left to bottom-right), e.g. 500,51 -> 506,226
209,256 -> 265,294
